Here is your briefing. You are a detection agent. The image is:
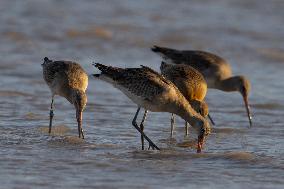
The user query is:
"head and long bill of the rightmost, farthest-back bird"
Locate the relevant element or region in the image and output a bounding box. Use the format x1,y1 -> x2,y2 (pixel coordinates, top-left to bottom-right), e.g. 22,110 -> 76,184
237,76 -> 252,126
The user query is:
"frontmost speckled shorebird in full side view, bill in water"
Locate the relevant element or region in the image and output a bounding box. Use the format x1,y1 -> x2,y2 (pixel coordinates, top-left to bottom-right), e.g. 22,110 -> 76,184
94,63 -> 210,152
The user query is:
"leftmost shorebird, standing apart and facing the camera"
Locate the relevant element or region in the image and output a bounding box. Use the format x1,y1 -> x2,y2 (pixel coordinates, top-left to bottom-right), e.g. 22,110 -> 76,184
42,57 -> 88,139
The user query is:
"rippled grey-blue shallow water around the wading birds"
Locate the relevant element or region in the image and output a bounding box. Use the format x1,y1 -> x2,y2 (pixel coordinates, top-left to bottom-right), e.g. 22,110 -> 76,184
0,0 -> 284,188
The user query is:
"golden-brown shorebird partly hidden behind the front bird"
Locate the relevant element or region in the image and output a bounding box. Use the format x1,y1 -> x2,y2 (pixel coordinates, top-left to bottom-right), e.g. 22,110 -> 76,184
160,62 -> 214,137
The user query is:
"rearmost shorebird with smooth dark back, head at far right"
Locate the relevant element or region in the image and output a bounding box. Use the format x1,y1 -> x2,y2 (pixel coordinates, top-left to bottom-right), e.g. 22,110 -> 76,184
152,46 -> 252,126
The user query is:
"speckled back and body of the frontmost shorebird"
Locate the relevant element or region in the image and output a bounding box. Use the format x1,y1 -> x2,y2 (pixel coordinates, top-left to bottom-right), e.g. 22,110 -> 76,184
95,64 -> 184,111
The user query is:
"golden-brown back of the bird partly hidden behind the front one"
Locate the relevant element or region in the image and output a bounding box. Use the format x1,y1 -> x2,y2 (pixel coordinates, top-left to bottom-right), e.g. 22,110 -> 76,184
160,62 -> 207,101
